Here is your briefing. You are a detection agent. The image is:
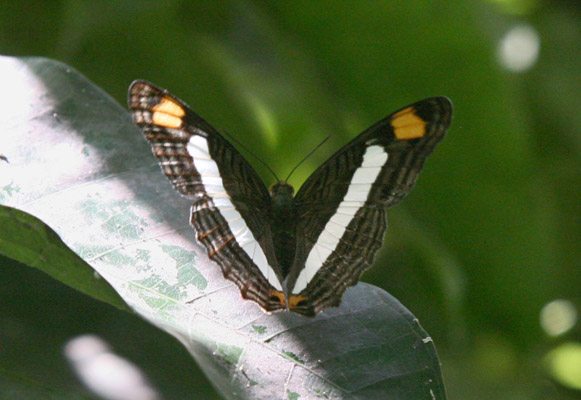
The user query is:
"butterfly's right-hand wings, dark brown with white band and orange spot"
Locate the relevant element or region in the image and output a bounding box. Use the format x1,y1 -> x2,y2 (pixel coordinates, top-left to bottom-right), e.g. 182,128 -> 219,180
288,97 -> 452,316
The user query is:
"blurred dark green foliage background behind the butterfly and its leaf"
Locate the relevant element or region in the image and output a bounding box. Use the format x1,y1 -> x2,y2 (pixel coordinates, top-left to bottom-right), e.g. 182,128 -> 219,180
0,0 -> 581,399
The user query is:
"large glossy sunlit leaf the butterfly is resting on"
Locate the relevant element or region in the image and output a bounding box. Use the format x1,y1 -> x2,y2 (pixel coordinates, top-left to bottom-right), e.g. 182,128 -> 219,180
0,57 -> 445,400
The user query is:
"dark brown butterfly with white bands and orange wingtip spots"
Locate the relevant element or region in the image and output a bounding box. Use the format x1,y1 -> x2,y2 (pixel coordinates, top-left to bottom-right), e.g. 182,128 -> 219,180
129,81 -> 452,316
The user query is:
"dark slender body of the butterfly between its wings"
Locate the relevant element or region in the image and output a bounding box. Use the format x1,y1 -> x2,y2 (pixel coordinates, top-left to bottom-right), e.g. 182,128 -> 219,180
270,181 -> 297,277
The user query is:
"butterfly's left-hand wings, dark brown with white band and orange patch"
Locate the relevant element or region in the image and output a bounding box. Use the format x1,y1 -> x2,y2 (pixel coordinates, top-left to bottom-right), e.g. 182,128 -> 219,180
129,81 -> 283,311
